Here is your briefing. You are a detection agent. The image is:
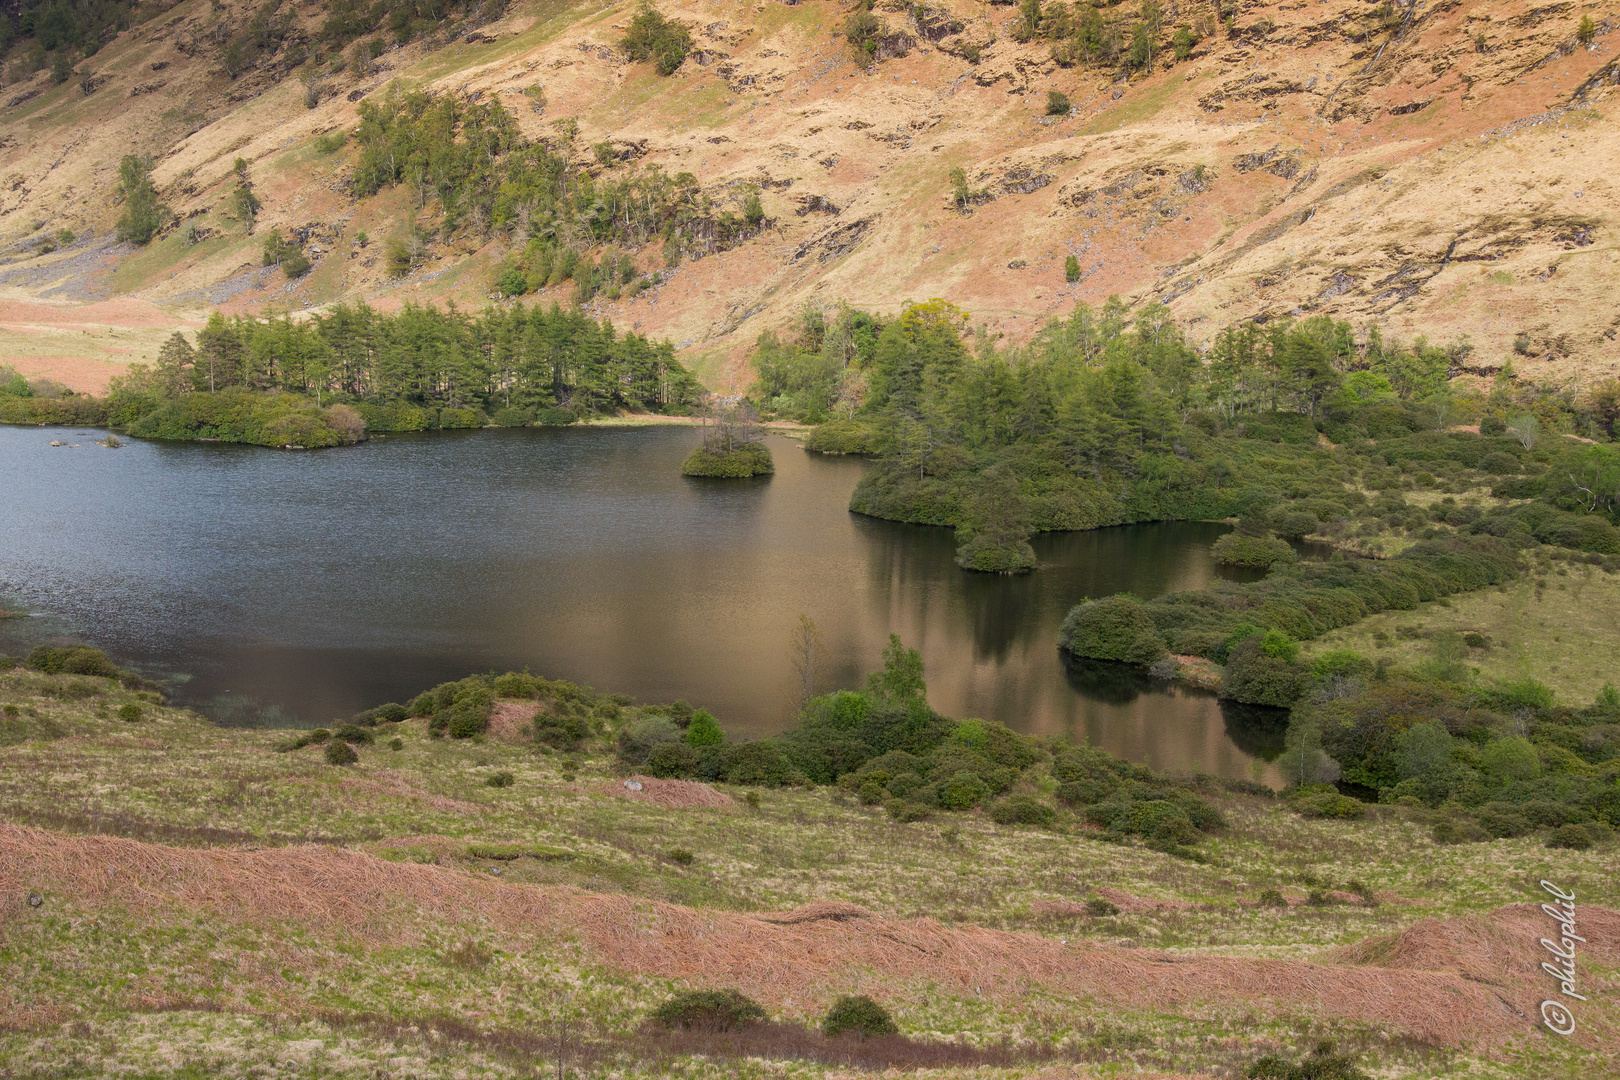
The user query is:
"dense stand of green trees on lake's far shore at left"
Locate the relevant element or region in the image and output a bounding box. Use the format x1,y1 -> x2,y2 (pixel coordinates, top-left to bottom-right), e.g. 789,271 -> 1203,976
87,299 -> 697,447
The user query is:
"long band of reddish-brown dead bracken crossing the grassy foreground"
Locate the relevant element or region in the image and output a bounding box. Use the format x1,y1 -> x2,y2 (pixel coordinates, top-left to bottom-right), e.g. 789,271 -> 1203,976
0,826 -> 1620,1048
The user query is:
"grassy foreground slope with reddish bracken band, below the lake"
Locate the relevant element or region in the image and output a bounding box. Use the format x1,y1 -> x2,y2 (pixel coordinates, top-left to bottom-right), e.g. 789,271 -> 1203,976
0,669 -> 1620,1077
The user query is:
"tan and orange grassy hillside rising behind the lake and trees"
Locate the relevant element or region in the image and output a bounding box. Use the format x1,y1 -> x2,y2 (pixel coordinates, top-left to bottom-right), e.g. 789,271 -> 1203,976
0,0 -> 1620,389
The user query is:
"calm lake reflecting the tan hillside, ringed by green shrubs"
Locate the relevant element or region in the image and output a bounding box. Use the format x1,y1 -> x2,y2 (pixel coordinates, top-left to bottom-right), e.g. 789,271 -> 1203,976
0,426 -> 1280,779
